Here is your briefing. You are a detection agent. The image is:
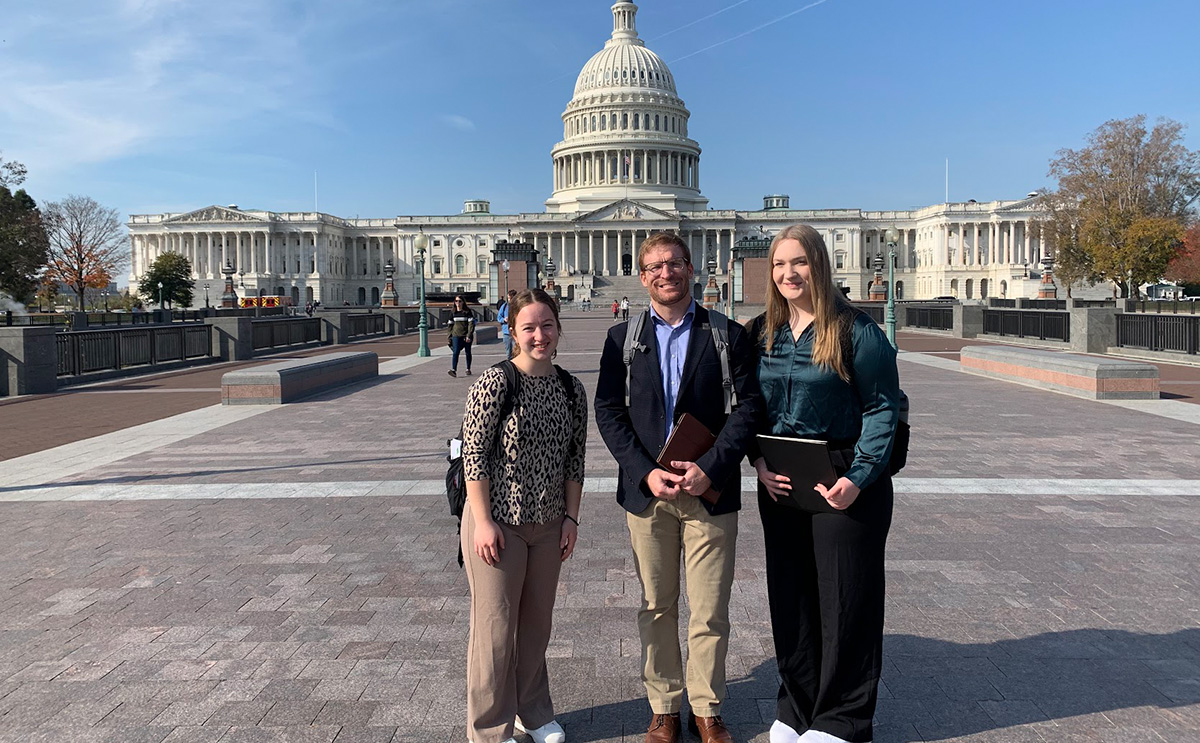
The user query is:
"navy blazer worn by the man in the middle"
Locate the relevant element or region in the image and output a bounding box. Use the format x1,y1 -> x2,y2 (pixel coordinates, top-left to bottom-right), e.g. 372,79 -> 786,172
595,304 -> 762,515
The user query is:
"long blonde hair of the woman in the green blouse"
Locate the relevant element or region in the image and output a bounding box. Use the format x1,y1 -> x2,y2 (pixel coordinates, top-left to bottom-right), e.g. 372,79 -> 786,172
762,224 -> 853,382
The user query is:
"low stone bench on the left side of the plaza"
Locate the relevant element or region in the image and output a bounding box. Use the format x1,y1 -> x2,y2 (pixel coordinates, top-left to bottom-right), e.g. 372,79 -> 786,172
221,352 -> 379,405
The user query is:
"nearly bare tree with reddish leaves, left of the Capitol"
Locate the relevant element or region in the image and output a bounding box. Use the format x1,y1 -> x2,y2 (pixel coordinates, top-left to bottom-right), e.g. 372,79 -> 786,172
44,196 -> 130,310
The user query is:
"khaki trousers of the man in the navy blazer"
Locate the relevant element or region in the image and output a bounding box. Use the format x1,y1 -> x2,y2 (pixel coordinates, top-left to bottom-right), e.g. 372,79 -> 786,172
626,495 -> 738,717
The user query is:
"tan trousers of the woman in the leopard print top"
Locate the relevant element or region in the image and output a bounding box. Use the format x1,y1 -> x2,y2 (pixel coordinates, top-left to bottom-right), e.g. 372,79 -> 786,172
462,504 -> 563,743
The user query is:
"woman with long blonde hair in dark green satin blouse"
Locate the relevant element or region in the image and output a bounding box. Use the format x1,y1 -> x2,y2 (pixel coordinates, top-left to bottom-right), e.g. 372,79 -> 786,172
750,224 -> 900,743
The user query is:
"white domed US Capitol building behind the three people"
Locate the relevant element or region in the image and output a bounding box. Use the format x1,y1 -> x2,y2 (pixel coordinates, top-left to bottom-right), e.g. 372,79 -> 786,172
128,1 -> 1042,305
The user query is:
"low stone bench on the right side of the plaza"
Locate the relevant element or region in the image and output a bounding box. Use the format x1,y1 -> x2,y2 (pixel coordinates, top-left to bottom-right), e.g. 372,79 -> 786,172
959,346 -> 1158,400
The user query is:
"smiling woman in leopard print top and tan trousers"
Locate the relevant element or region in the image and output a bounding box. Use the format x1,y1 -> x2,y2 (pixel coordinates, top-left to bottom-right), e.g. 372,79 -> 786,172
462,289 -> 588,743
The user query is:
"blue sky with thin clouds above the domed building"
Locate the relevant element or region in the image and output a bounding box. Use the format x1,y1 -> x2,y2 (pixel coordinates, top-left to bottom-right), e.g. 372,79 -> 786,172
0,0 -> 1200,217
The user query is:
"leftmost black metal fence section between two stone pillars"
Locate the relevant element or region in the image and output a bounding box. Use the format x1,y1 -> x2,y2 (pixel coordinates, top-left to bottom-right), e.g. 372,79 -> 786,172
54,323 -> 212,377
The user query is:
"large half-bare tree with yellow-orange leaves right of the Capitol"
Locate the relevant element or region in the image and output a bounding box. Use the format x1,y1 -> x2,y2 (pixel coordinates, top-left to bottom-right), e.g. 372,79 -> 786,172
1044,115 -> 1200,296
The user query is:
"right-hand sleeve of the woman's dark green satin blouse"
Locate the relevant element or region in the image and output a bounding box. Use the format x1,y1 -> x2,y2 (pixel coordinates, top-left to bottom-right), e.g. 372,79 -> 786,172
846,314 -> 900,489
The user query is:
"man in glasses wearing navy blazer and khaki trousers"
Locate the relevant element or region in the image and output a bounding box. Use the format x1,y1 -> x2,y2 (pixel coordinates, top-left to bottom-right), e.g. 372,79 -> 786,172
595,233 -> 760,743
